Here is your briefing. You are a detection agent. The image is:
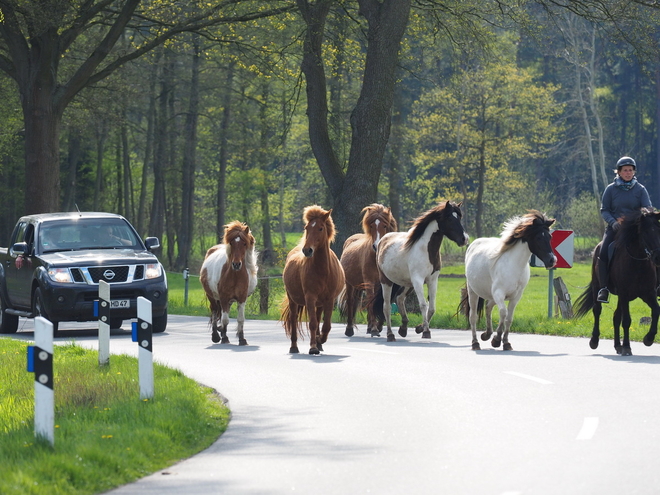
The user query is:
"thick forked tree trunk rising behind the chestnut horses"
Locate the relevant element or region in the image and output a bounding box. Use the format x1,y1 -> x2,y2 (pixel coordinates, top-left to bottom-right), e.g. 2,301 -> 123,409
297,0 -> 410,253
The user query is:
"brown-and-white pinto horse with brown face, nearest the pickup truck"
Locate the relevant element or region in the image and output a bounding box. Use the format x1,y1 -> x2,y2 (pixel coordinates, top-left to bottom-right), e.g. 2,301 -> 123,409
199,221 -> 258,345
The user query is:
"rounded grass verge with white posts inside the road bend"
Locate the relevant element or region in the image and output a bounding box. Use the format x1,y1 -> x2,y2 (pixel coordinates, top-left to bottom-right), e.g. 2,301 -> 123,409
0,338 -> 229,495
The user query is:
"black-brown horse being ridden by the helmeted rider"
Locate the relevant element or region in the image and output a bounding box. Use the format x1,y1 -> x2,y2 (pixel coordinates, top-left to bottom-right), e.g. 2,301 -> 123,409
573,209 -> 660,356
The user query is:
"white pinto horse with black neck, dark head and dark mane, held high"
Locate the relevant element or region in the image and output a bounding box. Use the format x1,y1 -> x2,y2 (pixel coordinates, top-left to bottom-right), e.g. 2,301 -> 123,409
371,201 -> 469,342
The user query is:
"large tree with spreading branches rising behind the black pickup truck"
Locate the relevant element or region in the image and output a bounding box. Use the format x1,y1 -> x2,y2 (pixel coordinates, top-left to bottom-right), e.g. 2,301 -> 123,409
0,0 -> 291,212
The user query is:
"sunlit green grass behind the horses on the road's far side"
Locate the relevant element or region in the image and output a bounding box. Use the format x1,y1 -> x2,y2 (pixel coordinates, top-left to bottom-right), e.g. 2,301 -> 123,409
168,261 -> 651,341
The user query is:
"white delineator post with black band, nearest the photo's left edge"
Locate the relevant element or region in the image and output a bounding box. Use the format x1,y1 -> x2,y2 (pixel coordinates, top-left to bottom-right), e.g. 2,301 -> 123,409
34,316 -> 55,445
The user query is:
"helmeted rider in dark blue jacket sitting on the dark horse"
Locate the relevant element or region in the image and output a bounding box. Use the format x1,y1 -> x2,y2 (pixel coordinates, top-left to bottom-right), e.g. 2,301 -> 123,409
597,156 -> 651,303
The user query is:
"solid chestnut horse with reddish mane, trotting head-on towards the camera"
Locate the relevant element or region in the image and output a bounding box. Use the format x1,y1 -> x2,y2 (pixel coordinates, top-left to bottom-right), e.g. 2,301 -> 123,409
280,205 -> 345,354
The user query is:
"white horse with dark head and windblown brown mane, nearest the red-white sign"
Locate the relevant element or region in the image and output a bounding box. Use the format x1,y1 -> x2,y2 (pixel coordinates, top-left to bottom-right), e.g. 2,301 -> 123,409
462,210 -> 557,351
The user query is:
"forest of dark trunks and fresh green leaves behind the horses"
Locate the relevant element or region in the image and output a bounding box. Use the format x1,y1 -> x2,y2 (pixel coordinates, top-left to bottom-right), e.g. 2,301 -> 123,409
0,0 -> 660,270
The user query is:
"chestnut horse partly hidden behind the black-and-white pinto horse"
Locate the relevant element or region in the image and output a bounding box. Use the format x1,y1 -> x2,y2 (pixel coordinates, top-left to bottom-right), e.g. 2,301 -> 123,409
339,203 -> 398,337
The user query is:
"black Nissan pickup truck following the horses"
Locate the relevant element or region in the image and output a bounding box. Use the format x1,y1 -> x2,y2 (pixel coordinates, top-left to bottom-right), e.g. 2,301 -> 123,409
0,212 -> 167,333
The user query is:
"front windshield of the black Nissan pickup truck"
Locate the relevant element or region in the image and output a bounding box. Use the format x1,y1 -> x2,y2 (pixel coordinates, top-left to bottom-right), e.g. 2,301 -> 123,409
39,218 -> 143,253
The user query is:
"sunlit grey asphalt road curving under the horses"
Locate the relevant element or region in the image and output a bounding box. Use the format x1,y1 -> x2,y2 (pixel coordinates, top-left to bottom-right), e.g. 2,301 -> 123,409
10,316 -> 660,495
